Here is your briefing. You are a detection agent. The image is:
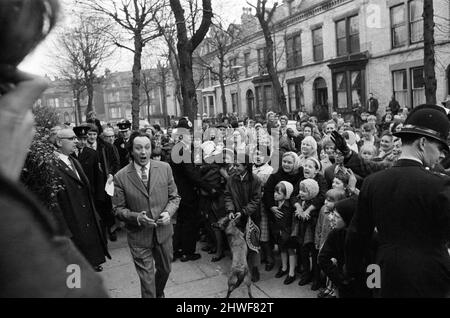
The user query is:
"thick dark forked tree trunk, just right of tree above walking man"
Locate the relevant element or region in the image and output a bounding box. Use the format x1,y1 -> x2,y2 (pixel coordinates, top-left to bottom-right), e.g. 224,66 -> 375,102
170,0 -> 213,121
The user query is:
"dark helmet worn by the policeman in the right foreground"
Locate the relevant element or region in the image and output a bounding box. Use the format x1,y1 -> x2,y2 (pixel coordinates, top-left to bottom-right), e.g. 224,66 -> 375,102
393,105 -> 450,151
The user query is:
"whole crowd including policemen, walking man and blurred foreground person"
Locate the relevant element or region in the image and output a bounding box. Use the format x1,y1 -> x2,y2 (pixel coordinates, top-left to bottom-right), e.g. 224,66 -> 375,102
0,0 -> 450,298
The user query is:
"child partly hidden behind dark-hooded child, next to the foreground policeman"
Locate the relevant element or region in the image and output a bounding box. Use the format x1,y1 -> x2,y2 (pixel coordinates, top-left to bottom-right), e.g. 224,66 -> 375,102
314,189 -> 346,298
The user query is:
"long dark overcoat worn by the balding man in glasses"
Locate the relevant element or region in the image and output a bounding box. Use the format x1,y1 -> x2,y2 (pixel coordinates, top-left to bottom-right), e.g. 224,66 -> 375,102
54,159 -> 111,266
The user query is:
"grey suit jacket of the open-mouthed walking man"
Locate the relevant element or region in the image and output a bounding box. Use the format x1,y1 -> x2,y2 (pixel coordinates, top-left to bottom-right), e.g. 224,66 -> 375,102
112,160 -> 180,247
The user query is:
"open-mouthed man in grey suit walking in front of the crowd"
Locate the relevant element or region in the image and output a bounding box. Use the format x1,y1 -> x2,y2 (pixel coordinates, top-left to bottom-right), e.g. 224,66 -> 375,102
113,132 -> 180,298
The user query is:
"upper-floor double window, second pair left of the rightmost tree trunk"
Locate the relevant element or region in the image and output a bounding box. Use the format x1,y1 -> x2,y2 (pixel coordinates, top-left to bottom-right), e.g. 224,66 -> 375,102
336,15 -> 360,56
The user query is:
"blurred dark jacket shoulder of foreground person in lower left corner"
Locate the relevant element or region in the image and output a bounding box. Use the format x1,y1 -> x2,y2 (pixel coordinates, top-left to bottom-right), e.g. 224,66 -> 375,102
0,174 -> 107,298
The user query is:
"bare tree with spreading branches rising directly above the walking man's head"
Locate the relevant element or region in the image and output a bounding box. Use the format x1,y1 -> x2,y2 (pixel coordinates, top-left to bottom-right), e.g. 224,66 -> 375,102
78,0 -> 166,130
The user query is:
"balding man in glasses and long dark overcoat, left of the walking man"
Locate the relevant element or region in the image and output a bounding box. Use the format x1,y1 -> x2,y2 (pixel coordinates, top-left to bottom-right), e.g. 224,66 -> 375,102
54,129 -> 111,271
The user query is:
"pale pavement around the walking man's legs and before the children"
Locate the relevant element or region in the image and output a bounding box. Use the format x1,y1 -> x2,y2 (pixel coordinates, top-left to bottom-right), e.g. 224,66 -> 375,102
100,230 -> 317,298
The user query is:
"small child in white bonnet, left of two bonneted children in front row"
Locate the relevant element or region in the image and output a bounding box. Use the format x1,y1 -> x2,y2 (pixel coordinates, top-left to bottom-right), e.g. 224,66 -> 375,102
274,181 -> 296,285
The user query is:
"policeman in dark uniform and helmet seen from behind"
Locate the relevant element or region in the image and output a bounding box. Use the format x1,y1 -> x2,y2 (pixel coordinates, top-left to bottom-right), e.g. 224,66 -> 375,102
345,105 -> 450,297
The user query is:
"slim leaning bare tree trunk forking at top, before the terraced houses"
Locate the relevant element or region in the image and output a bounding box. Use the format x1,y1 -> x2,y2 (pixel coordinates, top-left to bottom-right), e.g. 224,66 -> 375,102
248,0 -> 287,114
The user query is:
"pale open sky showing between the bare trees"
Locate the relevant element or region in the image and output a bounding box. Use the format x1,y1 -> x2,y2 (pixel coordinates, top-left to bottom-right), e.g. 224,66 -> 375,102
19,0 -> 274,76
